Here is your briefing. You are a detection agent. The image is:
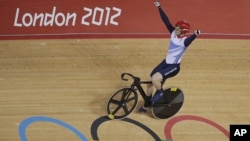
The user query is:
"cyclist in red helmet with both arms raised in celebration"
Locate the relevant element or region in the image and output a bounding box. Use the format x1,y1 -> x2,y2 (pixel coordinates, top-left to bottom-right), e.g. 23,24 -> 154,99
139,0 -> 201,112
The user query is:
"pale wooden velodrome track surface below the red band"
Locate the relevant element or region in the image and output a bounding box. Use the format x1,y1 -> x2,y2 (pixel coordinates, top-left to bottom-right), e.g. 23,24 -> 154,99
0,39 -> 250,141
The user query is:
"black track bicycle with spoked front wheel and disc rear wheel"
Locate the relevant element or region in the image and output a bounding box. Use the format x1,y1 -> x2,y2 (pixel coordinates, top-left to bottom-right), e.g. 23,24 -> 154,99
106,73 -> 184,119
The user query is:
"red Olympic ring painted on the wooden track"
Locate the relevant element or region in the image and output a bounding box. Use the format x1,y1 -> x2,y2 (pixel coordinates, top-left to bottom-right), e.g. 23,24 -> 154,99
165,115 -> 230,140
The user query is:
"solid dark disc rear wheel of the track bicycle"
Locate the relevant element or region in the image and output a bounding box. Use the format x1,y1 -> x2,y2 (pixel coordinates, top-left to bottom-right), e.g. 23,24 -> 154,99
152,87 -> 184,119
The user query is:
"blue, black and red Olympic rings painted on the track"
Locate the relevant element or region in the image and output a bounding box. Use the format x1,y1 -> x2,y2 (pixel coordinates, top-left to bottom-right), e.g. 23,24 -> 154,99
19,115 -> 230,141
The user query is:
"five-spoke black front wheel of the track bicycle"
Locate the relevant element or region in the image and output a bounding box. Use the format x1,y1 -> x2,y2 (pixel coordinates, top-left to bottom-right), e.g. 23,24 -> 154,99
106,88 -> 138,119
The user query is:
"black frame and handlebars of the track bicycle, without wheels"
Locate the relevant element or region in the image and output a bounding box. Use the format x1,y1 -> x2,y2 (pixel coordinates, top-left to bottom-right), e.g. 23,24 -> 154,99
121,73 -> 152,101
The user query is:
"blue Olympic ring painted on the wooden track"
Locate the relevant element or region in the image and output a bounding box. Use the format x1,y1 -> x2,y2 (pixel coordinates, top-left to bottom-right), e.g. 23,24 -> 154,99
19,116 -> 87,141
